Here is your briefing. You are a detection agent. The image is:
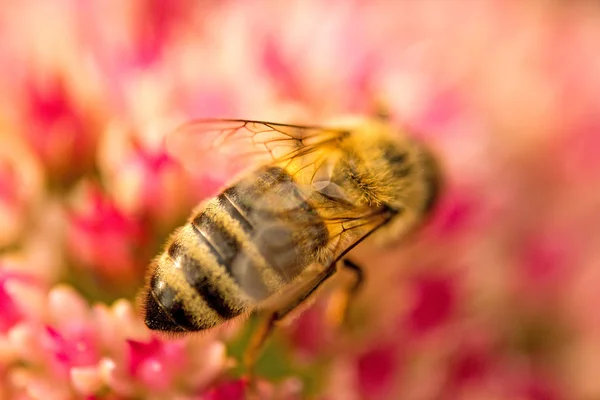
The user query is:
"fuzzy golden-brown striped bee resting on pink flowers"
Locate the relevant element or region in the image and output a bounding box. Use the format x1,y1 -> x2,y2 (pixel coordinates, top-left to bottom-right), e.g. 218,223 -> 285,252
143,118 -> 439,360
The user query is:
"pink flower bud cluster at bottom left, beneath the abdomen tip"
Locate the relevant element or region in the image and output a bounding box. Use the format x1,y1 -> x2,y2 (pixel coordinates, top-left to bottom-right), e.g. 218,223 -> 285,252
0,287 -> 230,398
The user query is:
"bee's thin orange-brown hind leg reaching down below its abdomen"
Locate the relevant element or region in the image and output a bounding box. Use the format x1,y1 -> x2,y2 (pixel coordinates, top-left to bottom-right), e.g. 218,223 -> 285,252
244,264 -> 336,382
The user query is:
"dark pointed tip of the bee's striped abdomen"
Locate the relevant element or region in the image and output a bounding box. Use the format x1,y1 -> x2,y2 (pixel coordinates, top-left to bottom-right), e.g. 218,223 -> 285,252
144,279 -> 197,332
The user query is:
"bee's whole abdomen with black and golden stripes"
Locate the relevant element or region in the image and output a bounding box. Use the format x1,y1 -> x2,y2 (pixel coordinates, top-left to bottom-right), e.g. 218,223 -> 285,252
146,167 -> 329,331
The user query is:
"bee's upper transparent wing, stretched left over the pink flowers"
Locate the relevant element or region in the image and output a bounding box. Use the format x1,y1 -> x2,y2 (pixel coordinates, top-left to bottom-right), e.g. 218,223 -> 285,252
166,119 -> 348,178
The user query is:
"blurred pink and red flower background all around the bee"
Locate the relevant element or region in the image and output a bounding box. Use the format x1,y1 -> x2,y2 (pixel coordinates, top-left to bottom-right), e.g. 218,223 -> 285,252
0,0 -> 600,400
